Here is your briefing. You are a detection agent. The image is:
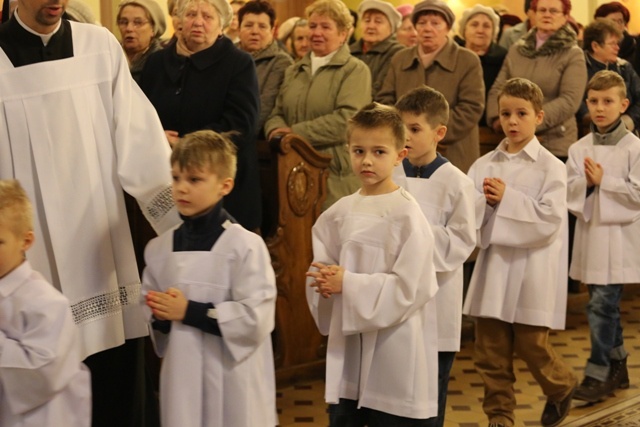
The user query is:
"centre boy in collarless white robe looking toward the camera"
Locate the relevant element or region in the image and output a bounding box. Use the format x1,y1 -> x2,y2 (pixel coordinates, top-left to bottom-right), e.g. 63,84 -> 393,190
307,104 -> 438,427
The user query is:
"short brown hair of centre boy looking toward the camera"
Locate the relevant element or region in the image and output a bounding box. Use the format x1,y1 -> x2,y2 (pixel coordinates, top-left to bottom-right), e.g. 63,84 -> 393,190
347,102 -> 407,150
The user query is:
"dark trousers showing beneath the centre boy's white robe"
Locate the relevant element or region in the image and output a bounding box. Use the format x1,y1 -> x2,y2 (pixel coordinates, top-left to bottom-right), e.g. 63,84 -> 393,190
327,399 -> 427,427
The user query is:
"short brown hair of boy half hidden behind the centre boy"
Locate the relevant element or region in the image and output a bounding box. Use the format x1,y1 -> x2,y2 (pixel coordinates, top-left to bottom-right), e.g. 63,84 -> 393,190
396,86 -> 449,129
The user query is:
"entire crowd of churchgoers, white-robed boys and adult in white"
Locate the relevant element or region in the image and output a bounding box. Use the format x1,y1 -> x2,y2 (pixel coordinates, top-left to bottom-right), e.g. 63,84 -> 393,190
0,0 -> 640,427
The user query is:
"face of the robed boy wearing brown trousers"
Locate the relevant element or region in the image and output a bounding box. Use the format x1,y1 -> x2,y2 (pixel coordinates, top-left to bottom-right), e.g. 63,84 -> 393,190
499,95 -> 544,153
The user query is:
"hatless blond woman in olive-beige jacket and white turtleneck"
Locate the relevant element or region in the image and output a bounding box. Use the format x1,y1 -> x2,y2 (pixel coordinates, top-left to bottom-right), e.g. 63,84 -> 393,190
265,0 -> 371,209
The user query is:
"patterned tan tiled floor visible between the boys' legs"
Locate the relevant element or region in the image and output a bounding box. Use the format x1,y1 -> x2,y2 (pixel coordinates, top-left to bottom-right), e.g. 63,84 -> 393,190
277,286 -> 640,427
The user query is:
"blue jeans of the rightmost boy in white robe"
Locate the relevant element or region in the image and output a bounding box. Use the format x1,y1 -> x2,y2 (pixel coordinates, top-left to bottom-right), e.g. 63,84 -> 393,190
584,285 -> 627,381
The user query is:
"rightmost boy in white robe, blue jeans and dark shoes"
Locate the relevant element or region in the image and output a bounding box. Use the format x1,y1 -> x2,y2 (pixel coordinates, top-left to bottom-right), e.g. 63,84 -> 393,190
567,71 -> 640,402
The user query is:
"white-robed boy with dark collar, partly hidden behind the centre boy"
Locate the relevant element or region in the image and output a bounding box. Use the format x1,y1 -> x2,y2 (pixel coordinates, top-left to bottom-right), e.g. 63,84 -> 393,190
394,86 -> 476,427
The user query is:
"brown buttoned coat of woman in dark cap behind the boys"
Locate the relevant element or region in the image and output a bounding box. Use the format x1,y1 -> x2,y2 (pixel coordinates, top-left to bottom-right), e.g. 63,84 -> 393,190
376,39 -> 485,173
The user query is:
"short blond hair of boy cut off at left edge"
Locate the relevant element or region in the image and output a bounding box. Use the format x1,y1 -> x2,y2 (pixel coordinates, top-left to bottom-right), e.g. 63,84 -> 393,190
0,180 -> 33,236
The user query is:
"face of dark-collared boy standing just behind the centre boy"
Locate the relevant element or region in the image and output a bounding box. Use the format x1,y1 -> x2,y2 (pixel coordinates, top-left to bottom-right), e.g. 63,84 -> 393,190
400,112 -> 447,166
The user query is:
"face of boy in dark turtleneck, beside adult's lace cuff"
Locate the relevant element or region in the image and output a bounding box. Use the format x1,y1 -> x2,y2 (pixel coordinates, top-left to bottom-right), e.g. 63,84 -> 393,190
171,163 -> 233,217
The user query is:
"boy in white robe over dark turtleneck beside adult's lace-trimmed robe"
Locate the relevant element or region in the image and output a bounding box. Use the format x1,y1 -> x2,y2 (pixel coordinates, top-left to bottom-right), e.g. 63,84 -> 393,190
143,131 -> 278,427
